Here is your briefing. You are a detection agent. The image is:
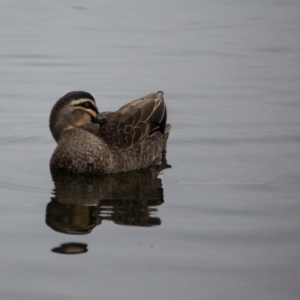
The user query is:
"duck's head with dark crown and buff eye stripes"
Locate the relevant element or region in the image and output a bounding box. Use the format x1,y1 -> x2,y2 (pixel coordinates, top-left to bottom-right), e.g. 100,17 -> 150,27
49,91 -> 104,142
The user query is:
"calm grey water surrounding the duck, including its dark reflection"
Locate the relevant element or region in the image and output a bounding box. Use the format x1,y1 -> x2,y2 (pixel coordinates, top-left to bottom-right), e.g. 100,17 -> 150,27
0,0 -> 300,300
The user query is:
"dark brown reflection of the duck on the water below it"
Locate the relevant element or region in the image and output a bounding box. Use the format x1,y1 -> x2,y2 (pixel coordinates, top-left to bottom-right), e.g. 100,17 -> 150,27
46,160 -> 170,237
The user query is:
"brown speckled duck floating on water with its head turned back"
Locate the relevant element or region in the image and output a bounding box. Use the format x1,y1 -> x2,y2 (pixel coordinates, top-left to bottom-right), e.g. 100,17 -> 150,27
49,91 -> 173,175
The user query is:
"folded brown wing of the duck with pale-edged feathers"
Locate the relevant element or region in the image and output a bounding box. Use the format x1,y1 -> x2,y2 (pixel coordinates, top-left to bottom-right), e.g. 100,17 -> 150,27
99,92 -> 167,149
